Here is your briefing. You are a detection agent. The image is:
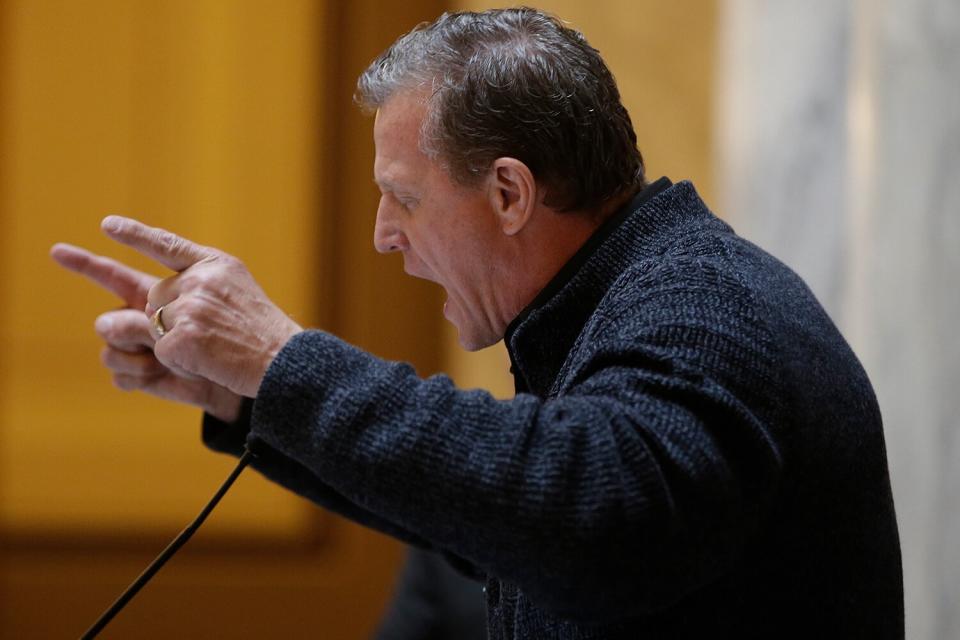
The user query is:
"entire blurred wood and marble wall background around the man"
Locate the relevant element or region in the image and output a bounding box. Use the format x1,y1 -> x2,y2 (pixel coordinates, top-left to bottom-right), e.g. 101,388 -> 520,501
0,0 -> 960,640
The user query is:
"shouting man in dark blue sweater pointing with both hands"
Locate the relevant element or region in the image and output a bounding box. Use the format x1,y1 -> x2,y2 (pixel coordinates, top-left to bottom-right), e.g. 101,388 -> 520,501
54,9 -> 903,638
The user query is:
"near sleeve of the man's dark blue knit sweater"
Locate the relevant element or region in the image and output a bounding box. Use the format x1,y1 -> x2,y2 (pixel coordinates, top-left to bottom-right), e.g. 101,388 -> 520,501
249,322 -> 778,621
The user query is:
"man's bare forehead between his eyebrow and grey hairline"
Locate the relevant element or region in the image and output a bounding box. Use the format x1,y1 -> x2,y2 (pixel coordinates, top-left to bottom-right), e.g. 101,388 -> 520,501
373,92 -> 429,188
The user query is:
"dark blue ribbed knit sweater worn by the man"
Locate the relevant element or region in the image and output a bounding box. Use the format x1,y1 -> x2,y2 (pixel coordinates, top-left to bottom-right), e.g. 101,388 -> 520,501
205,183 -> 903,639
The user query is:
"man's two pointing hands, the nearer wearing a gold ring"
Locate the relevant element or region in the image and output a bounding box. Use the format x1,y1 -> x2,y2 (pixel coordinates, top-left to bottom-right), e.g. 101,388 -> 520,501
51,216 -> 302,421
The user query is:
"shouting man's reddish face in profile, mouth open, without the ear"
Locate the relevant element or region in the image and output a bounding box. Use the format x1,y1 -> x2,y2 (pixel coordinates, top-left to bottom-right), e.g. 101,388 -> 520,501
373,91 -> 505,351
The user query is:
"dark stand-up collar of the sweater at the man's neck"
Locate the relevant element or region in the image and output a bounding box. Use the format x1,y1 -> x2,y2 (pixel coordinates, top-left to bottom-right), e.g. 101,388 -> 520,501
504,177 -> 699,396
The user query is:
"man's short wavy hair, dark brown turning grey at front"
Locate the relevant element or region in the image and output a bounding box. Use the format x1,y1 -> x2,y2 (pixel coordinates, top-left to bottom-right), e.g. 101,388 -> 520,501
355,7 -> 645,211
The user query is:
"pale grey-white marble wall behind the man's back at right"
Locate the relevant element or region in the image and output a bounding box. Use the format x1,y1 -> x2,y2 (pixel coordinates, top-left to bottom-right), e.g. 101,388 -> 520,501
716,0 -> 960,640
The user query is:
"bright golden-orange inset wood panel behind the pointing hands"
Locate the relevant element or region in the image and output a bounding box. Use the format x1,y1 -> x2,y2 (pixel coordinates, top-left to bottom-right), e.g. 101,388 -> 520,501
0,1 -> 319,536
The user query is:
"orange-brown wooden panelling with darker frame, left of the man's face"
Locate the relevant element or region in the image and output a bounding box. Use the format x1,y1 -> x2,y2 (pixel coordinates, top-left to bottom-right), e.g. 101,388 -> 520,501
0,0 -> 442,638
